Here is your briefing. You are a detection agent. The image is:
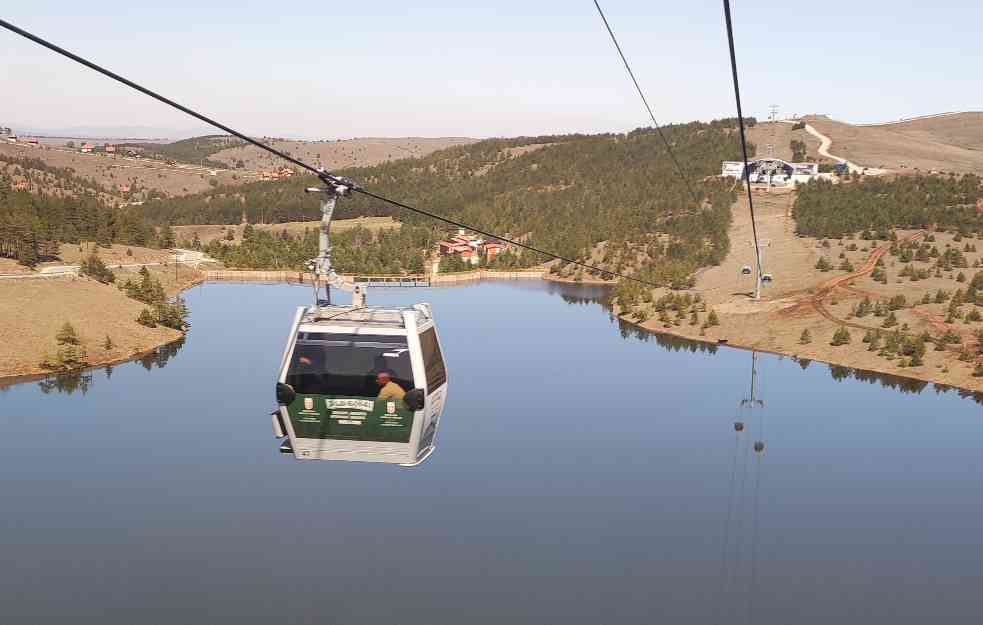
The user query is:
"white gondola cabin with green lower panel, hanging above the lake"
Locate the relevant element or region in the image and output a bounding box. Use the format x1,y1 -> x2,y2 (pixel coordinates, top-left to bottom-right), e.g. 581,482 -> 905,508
273,304 -> 447,466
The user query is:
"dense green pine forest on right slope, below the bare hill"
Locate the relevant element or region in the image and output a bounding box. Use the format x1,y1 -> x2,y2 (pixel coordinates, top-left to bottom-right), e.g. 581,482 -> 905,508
793,174 -> 983,237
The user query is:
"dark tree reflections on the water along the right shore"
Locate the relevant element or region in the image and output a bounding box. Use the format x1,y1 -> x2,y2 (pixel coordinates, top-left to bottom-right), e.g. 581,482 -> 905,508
547,282 -> 983,404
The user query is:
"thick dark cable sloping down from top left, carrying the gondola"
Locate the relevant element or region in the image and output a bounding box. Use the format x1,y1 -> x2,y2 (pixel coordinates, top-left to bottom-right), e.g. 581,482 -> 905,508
0,19 -> 661,289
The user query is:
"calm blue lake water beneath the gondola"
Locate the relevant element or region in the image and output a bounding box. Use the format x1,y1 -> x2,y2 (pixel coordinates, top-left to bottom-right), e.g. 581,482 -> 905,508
0,283 -> 983,625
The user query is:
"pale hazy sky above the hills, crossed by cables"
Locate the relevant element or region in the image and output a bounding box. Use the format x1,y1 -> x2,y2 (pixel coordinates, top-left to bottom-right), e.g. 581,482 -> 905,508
0,0 -> 983,138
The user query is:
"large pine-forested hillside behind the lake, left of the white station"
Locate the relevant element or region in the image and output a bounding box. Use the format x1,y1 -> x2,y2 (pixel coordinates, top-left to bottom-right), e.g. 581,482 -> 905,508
144,119 -> 752,273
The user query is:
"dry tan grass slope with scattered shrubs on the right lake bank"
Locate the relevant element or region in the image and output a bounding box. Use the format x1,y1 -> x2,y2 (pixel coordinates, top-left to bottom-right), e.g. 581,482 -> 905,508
642,192 -> 983,391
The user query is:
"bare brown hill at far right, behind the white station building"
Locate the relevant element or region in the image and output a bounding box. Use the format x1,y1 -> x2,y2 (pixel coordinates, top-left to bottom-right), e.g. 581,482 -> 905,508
804,113 -> 983,174
